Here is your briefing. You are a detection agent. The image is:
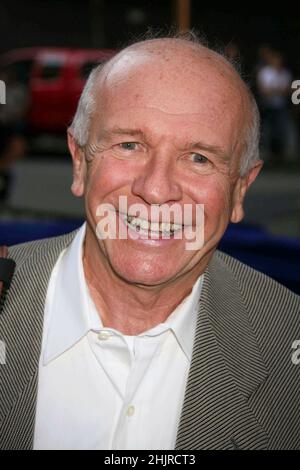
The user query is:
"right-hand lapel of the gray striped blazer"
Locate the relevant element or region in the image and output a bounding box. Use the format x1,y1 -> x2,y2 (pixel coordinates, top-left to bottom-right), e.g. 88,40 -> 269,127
176,254 -> 268,450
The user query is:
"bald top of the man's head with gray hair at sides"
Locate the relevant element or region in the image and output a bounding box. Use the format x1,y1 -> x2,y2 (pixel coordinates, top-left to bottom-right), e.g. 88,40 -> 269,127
71,38 -> 259,173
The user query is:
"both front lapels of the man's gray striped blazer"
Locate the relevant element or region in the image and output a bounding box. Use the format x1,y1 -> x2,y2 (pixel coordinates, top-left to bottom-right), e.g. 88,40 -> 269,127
0,231 -> 268,449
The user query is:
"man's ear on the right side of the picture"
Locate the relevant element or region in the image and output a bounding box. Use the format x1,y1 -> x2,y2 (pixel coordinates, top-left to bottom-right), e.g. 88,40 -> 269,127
230,160 -> 264,224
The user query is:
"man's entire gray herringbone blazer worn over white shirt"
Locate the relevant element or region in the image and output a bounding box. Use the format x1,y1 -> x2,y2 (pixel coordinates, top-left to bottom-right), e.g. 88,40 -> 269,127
0,231 -> 300,450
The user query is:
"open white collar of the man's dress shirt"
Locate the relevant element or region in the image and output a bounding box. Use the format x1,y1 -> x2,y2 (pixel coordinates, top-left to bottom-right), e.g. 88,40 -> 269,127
43,223 -> 203,365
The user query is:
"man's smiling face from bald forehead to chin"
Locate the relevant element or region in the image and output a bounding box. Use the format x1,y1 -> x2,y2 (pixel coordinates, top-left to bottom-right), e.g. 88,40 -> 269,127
69,46 -> 262,286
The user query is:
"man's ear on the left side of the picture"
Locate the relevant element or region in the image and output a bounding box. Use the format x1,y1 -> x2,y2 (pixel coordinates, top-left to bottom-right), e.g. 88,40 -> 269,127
68,130 -> 86,197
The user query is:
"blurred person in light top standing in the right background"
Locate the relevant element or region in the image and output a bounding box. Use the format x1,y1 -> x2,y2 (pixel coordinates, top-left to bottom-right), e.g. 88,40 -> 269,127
257,49 -> 292,163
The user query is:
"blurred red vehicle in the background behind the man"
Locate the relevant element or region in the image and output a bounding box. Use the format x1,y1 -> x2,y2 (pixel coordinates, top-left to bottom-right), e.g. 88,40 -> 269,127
0,48 -> 116,133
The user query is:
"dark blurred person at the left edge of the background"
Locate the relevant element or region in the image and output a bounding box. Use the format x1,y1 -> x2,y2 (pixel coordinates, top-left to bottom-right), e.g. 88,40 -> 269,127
0,69 -> 28,203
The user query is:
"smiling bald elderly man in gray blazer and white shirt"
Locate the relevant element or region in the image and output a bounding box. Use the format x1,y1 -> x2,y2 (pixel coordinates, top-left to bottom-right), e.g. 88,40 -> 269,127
0,38 -> 300,450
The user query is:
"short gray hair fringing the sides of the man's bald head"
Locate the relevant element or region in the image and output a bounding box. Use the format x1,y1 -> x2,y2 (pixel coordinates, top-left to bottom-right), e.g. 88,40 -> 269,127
69,32 -> 260,176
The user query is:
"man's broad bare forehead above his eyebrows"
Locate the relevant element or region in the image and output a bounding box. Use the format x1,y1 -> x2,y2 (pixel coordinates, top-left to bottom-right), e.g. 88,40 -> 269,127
90,43 -> 248,150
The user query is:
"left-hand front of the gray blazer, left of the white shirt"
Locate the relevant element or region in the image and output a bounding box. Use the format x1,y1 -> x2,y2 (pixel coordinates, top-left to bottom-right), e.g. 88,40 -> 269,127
0,231 -> 76,450
